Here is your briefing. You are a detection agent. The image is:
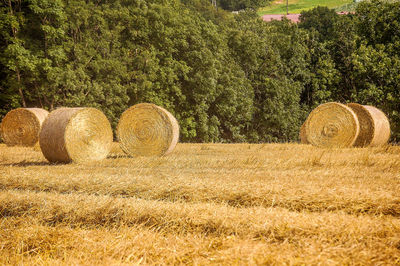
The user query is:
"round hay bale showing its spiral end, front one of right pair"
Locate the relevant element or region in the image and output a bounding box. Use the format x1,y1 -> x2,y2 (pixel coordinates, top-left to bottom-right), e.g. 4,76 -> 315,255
305,102 -> 360,148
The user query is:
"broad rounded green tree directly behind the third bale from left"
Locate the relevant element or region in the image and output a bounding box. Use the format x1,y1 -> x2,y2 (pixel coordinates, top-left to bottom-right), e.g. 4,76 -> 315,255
119,3 -> 252,141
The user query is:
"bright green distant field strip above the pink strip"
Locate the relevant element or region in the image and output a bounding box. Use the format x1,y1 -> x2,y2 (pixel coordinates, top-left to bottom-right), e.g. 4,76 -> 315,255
258,0 -> 353,15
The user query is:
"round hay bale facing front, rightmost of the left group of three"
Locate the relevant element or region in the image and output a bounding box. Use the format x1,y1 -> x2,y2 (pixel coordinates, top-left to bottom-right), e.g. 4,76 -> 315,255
117,103 -> 179,156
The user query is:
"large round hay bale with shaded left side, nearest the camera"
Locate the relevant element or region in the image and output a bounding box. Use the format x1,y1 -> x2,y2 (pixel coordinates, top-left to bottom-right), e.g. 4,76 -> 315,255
39,108 -> 113,163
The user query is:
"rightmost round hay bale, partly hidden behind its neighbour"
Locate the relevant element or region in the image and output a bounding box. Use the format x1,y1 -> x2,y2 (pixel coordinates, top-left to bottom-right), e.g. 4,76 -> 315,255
347,103 -> 390,147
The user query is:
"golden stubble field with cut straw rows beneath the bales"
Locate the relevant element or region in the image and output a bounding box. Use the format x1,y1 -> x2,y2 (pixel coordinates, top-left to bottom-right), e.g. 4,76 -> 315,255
0,144 -> 400,265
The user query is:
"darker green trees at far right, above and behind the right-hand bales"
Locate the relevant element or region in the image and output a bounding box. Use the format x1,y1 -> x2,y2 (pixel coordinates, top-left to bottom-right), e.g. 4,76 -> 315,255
299,0 -> 400,141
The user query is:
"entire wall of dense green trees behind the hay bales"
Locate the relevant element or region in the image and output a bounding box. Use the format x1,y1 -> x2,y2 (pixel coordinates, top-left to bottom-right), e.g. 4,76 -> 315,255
0,0 -> 400,142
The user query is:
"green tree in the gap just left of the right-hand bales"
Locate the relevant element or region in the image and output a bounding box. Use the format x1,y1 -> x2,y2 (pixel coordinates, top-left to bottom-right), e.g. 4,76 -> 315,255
228,12 -> 307,142
